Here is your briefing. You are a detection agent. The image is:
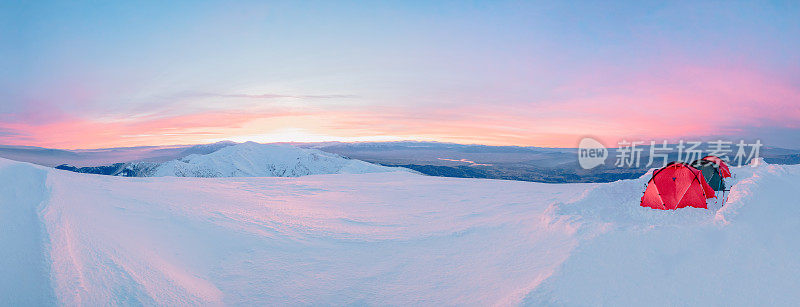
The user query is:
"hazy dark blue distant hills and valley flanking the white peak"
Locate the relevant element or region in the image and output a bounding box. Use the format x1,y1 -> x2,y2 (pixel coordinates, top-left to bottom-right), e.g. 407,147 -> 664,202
0,141 -> 800,183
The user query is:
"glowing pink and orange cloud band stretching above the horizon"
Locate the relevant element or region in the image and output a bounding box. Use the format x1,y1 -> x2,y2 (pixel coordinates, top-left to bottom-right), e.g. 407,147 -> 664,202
0,66 -> 800,148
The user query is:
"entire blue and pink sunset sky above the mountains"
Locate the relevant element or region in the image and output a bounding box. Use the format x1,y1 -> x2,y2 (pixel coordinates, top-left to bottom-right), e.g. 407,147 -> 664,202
0,1 -> 800,149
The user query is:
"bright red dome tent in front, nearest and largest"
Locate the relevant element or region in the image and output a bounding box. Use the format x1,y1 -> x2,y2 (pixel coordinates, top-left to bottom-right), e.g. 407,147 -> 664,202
641,162 -> 716,210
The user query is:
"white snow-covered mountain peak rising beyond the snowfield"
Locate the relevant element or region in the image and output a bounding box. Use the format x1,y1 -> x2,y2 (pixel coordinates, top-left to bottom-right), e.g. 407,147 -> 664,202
136,142 -> 402,177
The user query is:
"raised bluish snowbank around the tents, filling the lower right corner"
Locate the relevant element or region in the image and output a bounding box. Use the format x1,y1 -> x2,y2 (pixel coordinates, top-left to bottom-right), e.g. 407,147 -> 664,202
524,161 -> 800,306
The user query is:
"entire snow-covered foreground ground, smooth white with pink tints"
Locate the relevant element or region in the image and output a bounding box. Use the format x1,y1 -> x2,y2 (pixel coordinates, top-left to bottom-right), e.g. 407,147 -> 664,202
0,159 -> 800,306
